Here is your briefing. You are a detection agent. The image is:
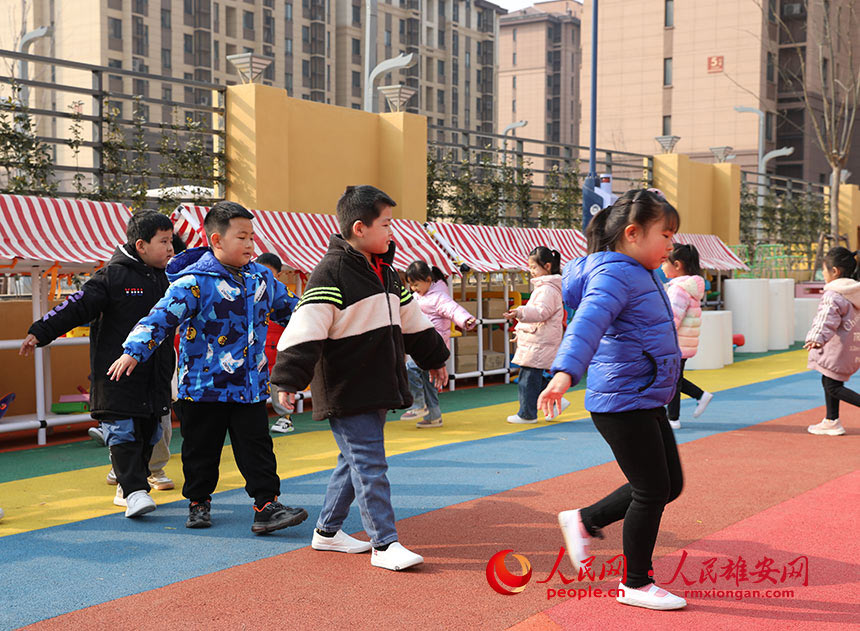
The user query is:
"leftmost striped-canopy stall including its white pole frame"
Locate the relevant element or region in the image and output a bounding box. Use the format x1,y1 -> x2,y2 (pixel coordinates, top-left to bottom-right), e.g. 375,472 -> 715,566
0,195 -> 131,445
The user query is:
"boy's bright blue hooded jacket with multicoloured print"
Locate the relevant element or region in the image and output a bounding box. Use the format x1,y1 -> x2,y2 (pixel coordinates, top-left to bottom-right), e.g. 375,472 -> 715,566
123,248 -> 298,403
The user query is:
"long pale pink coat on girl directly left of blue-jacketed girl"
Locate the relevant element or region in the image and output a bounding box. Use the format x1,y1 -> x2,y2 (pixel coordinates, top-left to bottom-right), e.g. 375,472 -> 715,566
513,274 -> 565,370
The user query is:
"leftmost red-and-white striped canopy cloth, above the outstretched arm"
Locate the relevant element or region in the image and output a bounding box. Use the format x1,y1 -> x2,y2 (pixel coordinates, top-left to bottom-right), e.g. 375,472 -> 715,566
0,195 -> 131,273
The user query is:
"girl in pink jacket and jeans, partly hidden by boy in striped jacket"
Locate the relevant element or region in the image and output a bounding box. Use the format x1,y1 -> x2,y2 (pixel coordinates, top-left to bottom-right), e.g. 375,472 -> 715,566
400,261 -> 477,428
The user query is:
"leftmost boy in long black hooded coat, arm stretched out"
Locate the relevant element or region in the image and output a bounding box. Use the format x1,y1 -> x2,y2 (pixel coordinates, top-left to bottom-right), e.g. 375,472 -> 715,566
20,210 -> 176,517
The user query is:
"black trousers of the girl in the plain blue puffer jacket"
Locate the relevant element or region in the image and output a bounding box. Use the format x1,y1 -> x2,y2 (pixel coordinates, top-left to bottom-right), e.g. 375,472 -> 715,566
580,408 -> 684,588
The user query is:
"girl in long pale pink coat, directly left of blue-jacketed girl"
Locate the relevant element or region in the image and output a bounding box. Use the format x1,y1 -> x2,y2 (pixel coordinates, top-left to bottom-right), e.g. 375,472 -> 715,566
504,246 -> 570,423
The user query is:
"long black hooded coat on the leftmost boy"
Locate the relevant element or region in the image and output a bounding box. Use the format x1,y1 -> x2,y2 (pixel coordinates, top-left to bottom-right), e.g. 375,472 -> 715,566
28,245 -> 176,420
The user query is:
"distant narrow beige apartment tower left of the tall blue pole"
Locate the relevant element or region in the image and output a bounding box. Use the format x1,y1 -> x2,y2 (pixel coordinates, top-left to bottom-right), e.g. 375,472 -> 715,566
497,0 -> 582,175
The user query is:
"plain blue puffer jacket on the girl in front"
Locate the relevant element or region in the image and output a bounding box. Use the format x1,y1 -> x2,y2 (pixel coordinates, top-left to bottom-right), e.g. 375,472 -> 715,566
552,252 -> 681,412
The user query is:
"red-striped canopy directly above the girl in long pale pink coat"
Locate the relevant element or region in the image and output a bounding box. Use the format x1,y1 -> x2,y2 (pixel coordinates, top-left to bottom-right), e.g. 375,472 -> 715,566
424,222 -> 586,272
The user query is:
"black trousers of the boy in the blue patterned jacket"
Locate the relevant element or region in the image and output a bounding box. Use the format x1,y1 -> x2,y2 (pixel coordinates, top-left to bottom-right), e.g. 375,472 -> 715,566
177,401 -> 281,506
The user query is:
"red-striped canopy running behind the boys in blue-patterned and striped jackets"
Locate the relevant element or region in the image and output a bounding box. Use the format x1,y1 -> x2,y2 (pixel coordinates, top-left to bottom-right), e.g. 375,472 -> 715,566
173,205 -> 456,274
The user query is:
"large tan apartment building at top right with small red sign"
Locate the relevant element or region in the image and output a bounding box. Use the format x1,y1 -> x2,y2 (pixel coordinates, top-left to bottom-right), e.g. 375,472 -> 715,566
580,0 -> 860,183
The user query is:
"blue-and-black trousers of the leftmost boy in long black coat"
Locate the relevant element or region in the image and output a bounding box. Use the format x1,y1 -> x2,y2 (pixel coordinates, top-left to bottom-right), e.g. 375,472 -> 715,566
102,416 -> 161,497
